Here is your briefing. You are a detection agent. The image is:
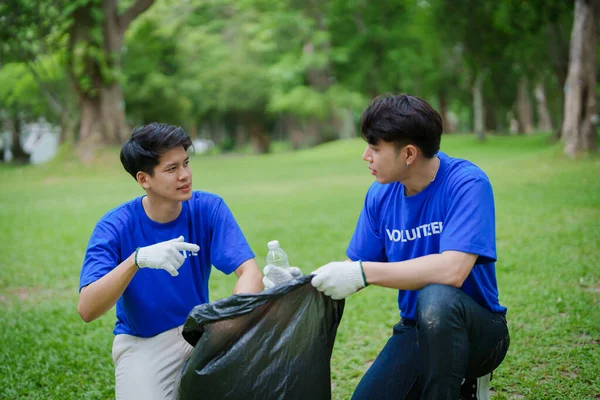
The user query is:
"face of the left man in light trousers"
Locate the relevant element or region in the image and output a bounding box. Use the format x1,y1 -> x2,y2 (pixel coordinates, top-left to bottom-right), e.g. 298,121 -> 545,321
143,147 -> 192,201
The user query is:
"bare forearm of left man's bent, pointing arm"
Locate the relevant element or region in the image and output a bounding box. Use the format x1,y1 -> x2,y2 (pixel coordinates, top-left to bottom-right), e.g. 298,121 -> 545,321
77,254 -> 138,322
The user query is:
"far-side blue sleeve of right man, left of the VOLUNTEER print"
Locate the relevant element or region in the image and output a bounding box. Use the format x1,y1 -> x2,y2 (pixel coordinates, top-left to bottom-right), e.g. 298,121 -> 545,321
346,190 -> 387,262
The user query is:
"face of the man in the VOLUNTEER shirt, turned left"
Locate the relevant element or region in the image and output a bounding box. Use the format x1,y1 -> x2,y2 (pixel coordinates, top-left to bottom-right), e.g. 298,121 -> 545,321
363,140 -> 406,183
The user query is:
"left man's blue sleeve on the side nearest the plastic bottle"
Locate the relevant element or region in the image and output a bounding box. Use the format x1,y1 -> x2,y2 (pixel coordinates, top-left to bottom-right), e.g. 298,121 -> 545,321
210,199 -> 254,274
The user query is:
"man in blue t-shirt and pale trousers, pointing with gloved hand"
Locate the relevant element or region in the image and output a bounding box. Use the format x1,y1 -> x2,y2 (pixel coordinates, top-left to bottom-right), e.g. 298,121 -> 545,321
78,123 -> 263,400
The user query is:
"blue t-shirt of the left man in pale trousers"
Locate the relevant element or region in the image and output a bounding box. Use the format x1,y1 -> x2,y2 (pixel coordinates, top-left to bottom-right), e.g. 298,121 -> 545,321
79,191 -> 254,337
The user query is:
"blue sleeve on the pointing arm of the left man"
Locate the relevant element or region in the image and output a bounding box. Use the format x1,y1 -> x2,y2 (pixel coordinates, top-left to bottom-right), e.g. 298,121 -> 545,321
79,221 -> 121,291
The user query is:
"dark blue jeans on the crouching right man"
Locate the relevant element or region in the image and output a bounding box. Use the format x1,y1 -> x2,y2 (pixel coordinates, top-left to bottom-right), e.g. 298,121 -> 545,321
352,285 -> 510,400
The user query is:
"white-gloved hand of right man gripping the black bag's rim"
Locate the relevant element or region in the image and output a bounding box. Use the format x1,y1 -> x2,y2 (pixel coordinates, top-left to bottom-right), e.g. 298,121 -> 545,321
310,261 -> 369,300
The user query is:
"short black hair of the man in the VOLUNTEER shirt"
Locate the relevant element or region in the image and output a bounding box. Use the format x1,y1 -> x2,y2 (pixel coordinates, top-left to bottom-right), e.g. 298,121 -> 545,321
360,94 -> 443,158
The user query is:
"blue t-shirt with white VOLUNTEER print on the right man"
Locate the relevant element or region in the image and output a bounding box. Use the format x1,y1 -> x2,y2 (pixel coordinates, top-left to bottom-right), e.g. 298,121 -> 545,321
346,152 -> 506,320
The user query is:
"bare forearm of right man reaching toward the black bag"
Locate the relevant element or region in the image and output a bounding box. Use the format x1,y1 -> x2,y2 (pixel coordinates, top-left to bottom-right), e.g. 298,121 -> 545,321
363,252 -> 477,290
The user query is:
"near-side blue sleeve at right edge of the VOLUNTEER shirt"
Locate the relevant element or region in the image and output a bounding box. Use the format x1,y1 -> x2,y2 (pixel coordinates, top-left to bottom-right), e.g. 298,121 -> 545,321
440,176 -> 496,264
